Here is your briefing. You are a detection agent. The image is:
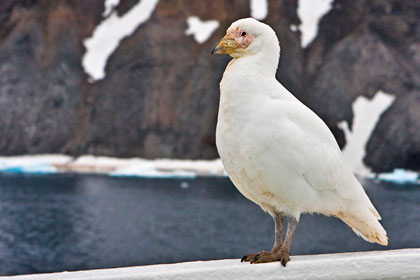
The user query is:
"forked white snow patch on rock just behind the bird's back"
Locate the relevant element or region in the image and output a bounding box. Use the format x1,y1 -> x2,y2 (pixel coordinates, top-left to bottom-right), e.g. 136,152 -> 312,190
338,91 -> 395,175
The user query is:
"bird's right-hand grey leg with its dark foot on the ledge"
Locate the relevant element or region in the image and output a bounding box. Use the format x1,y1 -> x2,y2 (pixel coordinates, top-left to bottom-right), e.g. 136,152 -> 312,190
251,216 -> 298,266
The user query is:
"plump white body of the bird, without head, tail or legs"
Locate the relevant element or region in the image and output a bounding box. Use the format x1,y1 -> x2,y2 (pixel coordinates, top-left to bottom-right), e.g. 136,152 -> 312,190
216,57 -> 370,219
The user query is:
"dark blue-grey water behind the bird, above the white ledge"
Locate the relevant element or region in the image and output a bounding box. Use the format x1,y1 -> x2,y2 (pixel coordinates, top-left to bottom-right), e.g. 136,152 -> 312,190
0,175 -> 420,275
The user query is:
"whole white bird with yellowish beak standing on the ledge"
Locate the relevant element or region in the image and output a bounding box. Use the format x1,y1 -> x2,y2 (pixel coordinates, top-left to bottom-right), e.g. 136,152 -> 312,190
212,18 -> 388,266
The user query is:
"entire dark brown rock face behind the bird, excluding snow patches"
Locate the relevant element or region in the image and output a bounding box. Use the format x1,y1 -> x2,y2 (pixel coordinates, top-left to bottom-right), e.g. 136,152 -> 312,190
0,0 -> 420,171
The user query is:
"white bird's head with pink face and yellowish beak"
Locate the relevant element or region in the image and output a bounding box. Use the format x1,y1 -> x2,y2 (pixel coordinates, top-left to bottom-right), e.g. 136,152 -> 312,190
211,18 -> 280,58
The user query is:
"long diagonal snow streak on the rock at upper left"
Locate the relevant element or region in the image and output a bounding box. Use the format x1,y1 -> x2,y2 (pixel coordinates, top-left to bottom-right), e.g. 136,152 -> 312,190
82,0 -> 159,82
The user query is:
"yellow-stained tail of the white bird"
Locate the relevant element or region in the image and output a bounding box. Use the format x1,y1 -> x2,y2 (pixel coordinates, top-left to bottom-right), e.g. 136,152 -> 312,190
336,207 -> 388,246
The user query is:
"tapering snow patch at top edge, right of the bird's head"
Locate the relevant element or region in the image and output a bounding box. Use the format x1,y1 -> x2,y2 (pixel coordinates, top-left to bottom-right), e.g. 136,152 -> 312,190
298,0 -> 334,48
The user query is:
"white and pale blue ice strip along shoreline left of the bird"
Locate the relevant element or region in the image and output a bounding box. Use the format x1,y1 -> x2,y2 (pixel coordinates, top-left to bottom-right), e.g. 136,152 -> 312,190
0,155 -> 226,177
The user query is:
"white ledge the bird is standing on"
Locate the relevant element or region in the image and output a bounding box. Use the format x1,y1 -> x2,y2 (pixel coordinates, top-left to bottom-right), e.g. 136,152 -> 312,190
0,249 -> 420,280
